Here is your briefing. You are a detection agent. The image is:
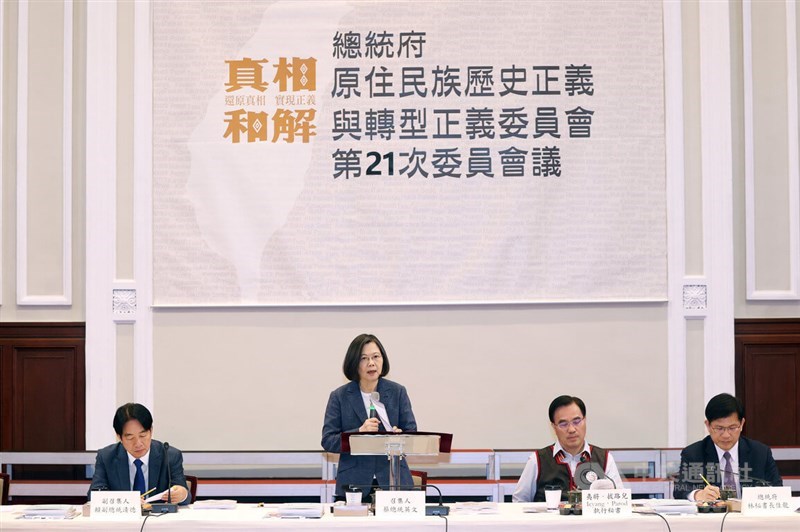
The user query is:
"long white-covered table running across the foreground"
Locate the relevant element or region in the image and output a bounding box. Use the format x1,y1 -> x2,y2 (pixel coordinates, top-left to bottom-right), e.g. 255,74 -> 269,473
0,503 -> 800,532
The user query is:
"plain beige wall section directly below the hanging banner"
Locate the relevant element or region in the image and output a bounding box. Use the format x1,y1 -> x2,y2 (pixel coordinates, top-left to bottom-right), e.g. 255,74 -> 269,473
154,305 -> 666,449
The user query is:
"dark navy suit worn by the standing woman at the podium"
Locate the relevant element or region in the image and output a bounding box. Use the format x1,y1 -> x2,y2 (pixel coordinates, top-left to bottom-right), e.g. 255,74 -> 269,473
322,378 -> 417,497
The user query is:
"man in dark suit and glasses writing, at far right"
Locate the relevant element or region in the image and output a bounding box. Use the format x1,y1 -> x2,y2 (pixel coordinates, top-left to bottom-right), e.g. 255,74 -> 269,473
674,393 -> 783,502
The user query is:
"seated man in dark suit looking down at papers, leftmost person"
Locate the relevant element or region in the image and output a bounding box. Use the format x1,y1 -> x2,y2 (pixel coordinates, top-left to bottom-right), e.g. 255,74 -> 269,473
89,403 -> 190,504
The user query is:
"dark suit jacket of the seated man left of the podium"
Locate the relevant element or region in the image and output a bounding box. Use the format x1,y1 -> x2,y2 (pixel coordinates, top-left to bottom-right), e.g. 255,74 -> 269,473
89,440 -> 192,504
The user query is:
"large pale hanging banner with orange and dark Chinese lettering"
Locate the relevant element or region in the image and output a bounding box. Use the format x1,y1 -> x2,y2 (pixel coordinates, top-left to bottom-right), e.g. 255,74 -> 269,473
153,0 -> 667,306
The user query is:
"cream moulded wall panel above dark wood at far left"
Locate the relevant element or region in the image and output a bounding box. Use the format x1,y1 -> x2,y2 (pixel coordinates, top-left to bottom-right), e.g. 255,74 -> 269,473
0,2 -> 85,322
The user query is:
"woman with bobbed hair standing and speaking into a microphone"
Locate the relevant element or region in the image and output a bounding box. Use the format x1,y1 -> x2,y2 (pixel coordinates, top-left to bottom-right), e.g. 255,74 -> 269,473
322,334 -> 417,500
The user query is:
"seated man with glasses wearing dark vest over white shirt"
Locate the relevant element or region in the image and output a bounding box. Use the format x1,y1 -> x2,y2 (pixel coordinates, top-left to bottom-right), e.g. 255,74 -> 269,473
511,395 -> 622,502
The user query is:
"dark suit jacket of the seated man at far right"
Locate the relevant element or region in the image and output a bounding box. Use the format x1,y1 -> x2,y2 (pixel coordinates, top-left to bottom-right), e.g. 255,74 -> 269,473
673,436 -> 783,499
